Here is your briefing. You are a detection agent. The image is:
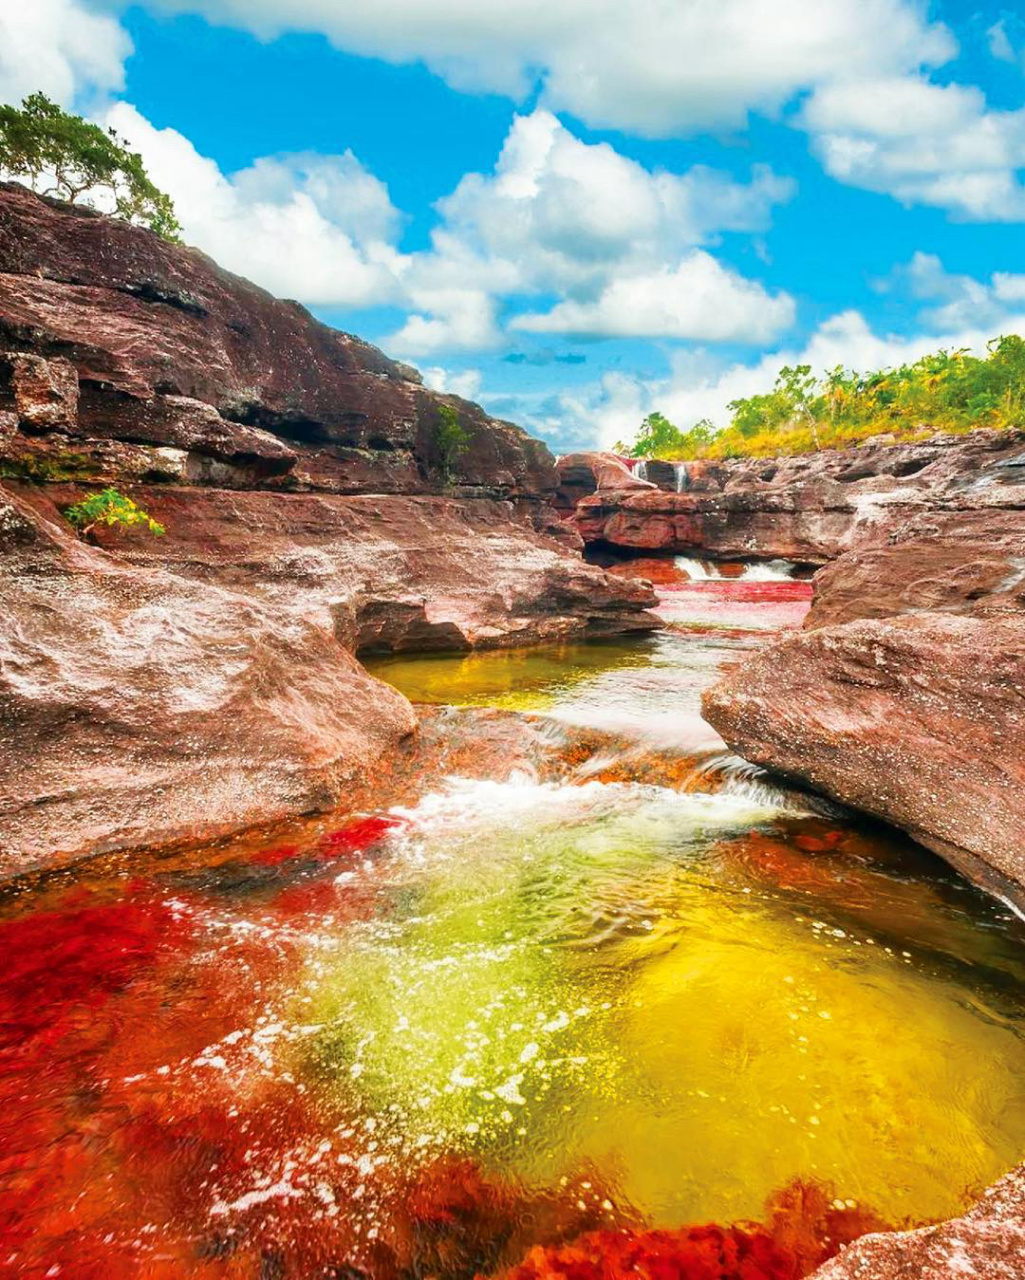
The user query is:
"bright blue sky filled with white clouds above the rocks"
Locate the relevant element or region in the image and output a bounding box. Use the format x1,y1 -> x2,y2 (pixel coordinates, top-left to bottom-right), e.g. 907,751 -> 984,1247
0,0 -> 1025,452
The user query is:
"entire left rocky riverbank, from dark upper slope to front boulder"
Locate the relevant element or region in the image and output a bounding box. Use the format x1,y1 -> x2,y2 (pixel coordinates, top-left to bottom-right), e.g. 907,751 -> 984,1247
0,184 -> 658,874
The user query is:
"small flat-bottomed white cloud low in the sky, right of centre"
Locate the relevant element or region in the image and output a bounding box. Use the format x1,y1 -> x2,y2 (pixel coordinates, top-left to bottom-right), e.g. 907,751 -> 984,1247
512,250 -> 795,343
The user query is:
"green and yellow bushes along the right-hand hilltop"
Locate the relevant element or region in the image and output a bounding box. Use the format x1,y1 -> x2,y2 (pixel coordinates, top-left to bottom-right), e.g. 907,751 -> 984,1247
617,334 -> 1025,461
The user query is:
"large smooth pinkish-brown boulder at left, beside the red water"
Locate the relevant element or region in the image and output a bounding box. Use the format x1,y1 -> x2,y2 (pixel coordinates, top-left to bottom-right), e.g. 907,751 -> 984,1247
0,483 -> 415,876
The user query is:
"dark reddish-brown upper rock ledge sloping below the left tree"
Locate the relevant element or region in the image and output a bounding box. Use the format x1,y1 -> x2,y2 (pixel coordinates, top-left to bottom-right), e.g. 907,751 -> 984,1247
0,183 -> 558,499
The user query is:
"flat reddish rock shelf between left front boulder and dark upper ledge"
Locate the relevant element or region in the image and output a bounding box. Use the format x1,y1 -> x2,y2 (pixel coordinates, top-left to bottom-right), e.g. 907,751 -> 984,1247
13,485 -> 659,652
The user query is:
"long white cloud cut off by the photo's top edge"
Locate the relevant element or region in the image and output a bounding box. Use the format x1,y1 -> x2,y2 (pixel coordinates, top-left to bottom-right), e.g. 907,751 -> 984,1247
145,0 -> 956,136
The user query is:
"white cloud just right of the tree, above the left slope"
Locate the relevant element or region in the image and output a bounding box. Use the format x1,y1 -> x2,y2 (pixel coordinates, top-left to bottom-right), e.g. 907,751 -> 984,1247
97,102 -> 399,307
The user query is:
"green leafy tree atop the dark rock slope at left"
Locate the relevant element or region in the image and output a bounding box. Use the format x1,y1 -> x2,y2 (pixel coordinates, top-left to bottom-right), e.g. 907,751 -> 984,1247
0,93 -> 182,243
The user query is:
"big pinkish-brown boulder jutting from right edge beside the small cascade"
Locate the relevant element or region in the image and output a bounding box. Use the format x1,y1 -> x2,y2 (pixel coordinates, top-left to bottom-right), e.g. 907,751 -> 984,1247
703,613 -> 1025,901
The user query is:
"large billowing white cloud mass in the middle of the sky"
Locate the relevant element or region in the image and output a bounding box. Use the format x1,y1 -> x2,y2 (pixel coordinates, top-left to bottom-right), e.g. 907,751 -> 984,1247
392,110 -> 792,356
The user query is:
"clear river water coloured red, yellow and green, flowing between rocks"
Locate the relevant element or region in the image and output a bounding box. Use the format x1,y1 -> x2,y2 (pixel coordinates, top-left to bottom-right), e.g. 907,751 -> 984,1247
0,571 -> 1025,1280
